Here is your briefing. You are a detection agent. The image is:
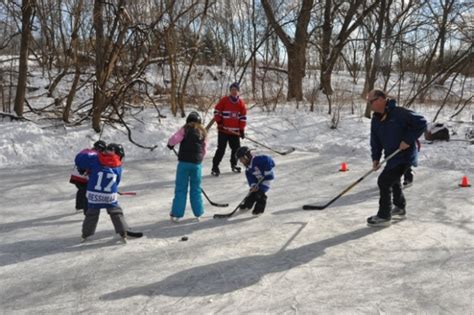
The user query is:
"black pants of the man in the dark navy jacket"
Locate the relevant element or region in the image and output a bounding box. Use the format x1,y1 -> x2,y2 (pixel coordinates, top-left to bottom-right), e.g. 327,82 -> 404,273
377,164 -> 410,219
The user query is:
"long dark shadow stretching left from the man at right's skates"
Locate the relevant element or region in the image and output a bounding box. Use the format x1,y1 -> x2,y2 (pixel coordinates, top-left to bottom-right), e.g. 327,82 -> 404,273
100,227 -> 380,300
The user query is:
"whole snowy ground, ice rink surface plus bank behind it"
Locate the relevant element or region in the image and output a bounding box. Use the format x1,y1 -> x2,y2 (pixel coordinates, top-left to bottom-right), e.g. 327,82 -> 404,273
0,105 -> 474,314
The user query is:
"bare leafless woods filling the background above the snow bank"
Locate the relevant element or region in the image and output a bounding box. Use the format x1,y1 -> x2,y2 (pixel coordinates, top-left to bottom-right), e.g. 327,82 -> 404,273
0,0 -> 474,133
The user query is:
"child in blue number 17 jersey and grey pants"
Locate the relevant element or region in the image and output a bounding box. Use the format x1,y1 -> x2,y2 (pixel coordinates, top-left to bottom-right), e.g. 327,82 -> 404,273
75,143 -> 128,242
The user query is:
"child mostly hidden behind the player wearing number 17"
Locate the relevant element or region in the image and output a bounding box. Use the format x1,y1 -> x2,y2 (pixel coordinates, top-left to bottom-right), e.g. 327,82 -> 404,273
69,140 -> 107,215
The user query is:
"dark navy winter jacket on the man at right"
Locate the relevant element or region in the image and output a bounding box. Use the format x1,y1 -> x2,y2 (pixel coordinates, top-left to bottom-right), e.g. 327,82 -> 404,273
370,100 -> 427,169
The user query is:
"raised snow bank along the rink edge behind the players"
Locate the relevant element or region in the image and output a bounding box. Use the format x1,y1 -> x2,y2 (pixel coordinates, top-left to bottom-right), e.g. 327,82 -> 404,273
0,104 -> 474,171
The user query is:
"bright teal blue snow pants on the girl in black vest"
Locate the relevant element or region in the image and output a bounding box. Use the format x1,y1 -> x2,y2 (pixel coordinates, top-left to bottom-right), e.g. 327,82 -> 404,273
170,161 -> 204,218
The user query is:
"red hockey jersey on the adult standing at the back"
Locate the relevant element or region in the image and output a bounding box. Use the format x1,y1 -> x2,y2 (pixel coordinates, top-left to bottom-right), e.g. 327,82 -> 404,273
214,96 -> 247,135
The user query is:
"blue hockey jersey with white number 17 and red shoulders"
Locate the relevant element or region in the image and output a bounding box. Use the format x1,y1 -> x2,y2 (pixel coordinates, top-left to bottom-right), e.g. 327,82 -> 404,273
75,153 -> 122,209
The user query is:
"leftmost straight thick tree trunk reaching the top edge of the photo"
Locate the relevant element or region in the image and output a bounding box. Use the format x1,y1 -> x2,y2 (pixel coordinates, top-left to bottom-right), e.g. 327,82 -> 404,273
14,0 -> 34,116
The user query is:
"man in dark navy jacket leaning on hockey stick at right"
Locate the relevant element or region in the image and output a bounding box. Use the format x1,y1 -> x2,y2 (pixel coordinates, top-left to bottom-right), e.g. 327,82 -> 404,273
367,90 -> 427,226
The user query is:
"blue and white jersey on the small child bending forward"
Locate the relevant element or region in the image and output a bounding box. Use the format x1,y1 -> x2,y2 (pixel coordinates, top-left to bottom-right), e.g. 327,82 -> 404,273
245,155 -> 275,192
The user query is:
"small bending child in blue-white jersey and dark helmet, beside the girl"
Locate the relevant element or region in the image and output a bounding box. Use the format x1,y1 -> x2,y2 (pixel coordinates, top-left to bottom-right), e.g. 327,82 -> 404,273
235,146 -> 275,215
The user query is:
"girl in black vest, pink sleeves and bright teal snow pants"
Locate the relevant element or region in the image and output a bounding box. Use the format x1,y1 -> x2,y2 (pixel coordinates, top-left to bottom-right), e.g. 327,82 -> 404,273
168,112 -> 207,222
